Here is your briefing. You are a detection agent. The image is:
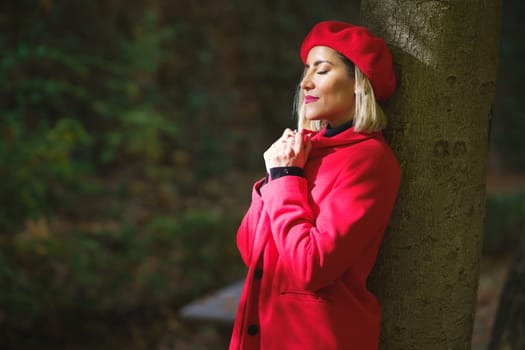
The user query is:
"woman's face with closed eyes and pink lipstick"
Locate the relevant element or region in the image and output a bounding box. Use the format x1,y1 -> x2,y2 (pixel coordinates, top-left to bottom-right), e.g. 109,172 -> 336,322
300,46 -> 355,127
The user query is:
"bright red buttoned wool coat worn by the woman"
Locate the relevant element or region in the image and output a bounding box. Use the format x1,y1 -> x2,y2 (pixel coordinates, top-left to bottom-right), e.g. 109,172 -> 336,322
230,128 -> 400,350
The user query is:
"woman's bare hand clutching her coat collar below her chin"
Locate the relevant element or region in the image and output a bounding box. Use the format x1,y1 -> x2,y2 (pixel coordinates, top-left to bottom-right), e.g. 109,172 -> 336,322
264,129 -> 312,172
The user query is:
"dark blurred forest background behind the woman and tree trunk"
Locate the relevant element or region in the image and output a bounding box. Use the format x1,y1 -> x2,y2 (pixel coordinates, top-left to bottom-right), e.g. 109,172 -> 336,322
0,0 -> 525,349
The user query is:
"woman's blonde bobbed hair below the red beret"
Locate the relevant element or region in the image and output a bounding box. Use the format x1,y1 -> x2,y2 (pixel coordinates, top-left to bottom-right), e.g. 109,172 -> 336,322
294,62 -> 387,133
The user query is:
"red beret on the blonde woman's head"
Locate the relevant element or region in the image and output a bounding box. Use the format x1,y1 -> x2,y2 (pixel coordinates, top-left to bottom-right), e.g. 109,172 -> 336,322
301,21 -> 396,101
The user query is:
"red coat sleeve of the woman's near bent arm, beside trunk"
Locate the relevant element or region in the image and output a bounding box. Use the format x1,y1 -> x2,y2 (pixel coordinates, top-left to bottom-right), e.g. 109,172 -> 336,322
261,148 -> 400,291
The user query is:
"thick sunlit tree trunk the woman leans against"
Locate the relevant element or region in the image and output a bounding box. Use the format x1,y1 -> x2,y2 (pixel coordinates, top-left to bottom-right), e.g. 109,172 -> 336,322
361,0 -> 500,350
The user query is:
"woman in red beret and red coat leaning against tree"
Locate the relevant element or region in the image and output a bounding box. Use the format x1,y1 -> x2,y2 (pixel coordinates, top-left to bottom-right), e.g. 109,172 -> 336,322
230,21 -> 400,350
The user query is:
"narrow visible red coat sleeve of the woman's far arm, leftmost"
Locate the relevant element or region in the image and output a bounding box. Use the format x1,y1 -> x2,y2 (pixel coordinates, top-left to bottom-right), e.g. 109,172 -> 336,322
236,179 -> 264,266
